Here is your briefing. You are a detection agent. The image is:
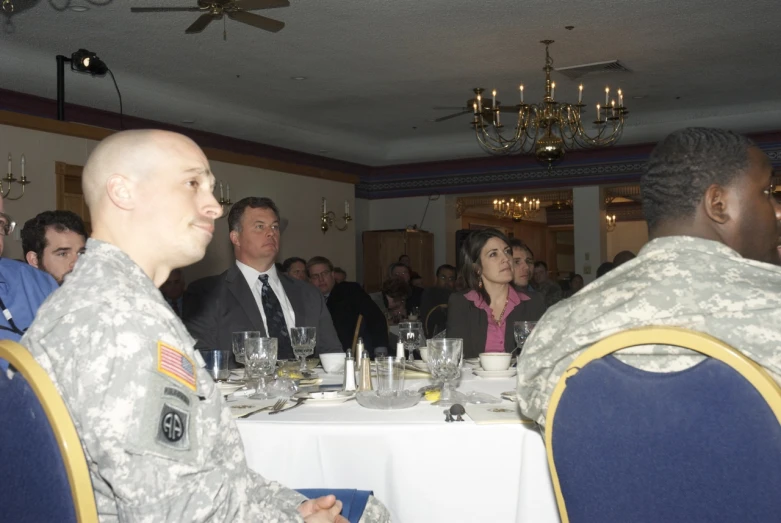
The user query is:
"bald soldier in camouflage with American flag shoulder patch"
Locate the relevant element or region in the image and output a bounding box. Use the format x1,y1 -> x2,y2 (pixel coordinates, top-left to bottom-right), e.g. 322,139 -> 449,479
21,131 -> 387,523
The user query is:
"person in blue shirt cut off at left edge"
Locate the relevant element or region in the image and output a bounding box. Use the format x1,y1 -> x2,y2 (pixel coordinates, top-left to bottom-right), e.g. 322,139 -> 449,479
0,194 -> 57,352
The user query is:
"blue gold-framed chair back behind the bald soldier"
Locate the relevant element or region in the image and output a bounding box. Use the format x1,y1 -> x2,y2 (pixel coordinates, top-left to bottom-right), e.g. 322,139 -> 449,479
0,340 -> 98,523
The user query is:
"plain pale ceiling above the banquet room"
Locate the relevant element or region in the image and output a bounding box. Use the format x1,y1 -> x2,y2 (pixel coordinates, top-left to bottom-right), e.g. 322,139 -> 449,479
0,0 -> 781,165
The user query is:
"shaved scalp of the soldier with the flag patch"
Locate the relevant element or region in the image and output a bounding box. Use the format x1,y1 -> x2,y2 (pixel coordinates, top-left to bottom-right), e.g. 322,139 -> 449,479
82,129 -> 208,212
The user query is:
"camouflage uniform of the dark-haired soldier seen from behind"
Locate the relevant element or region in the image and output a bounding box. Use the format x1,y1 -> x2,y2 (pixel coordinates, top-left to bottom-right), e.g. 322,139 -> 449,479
518,236 -> 781,425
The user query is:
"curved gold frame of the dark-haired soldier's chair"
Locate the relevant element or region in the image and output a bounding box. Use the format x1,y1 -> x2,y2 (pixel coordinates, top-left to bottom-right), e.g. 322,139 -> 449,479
545,327 -> 781,523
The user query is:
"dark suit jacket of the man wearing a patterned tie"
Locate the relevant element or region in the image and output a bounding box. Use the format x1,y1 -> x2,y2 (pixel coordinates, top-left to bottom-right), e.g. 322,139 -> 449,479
182,263 -> 342,359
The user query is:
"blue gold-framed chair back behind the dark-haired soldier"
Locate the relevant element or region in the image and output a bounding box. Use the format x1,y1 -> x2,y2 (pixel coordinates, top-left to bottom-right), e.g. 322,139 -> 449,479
545,327 -> 781,523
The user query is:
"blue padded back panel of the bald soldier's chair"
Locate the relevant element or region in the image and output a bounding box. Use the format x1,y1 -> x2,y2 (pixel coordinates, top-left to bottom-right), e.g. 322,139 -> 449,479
0,360 -> 76,523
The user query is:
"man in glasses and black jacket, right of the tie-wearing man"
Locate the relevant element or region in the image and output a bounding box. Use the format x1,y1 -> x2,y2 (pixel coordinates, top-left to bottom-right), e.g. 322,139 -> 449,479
306,256 -> 392,358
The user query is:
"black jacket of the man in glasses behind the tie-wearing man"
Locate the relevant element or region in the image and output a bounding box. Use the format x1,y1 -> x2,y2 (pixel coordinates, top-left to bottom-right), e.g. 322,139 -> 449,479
326,281 -> 395,358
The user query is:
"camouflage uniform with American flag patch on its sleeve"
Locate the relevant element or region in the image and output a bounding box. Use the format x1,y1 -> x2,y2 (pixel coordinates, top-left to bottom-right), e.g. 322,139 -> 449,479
21,240 -> 384,523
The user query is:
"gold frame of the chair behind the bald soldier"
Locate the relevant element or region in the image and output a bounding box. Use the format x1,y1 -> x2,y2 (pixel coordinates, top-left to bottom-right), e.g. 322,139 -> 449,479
0,340 -> 98,523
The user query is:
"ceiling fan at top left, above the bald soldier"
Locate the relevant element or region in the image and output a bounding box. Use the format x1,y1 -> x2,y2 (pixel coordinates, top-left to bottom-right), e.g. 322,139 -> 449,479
130,0 -> 290,34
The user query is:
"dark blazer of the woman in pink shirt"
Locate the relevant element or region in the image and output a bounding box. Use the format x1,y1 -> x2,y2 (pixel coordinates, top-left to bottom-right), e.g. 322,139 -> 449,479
447,292 -> 545,358
